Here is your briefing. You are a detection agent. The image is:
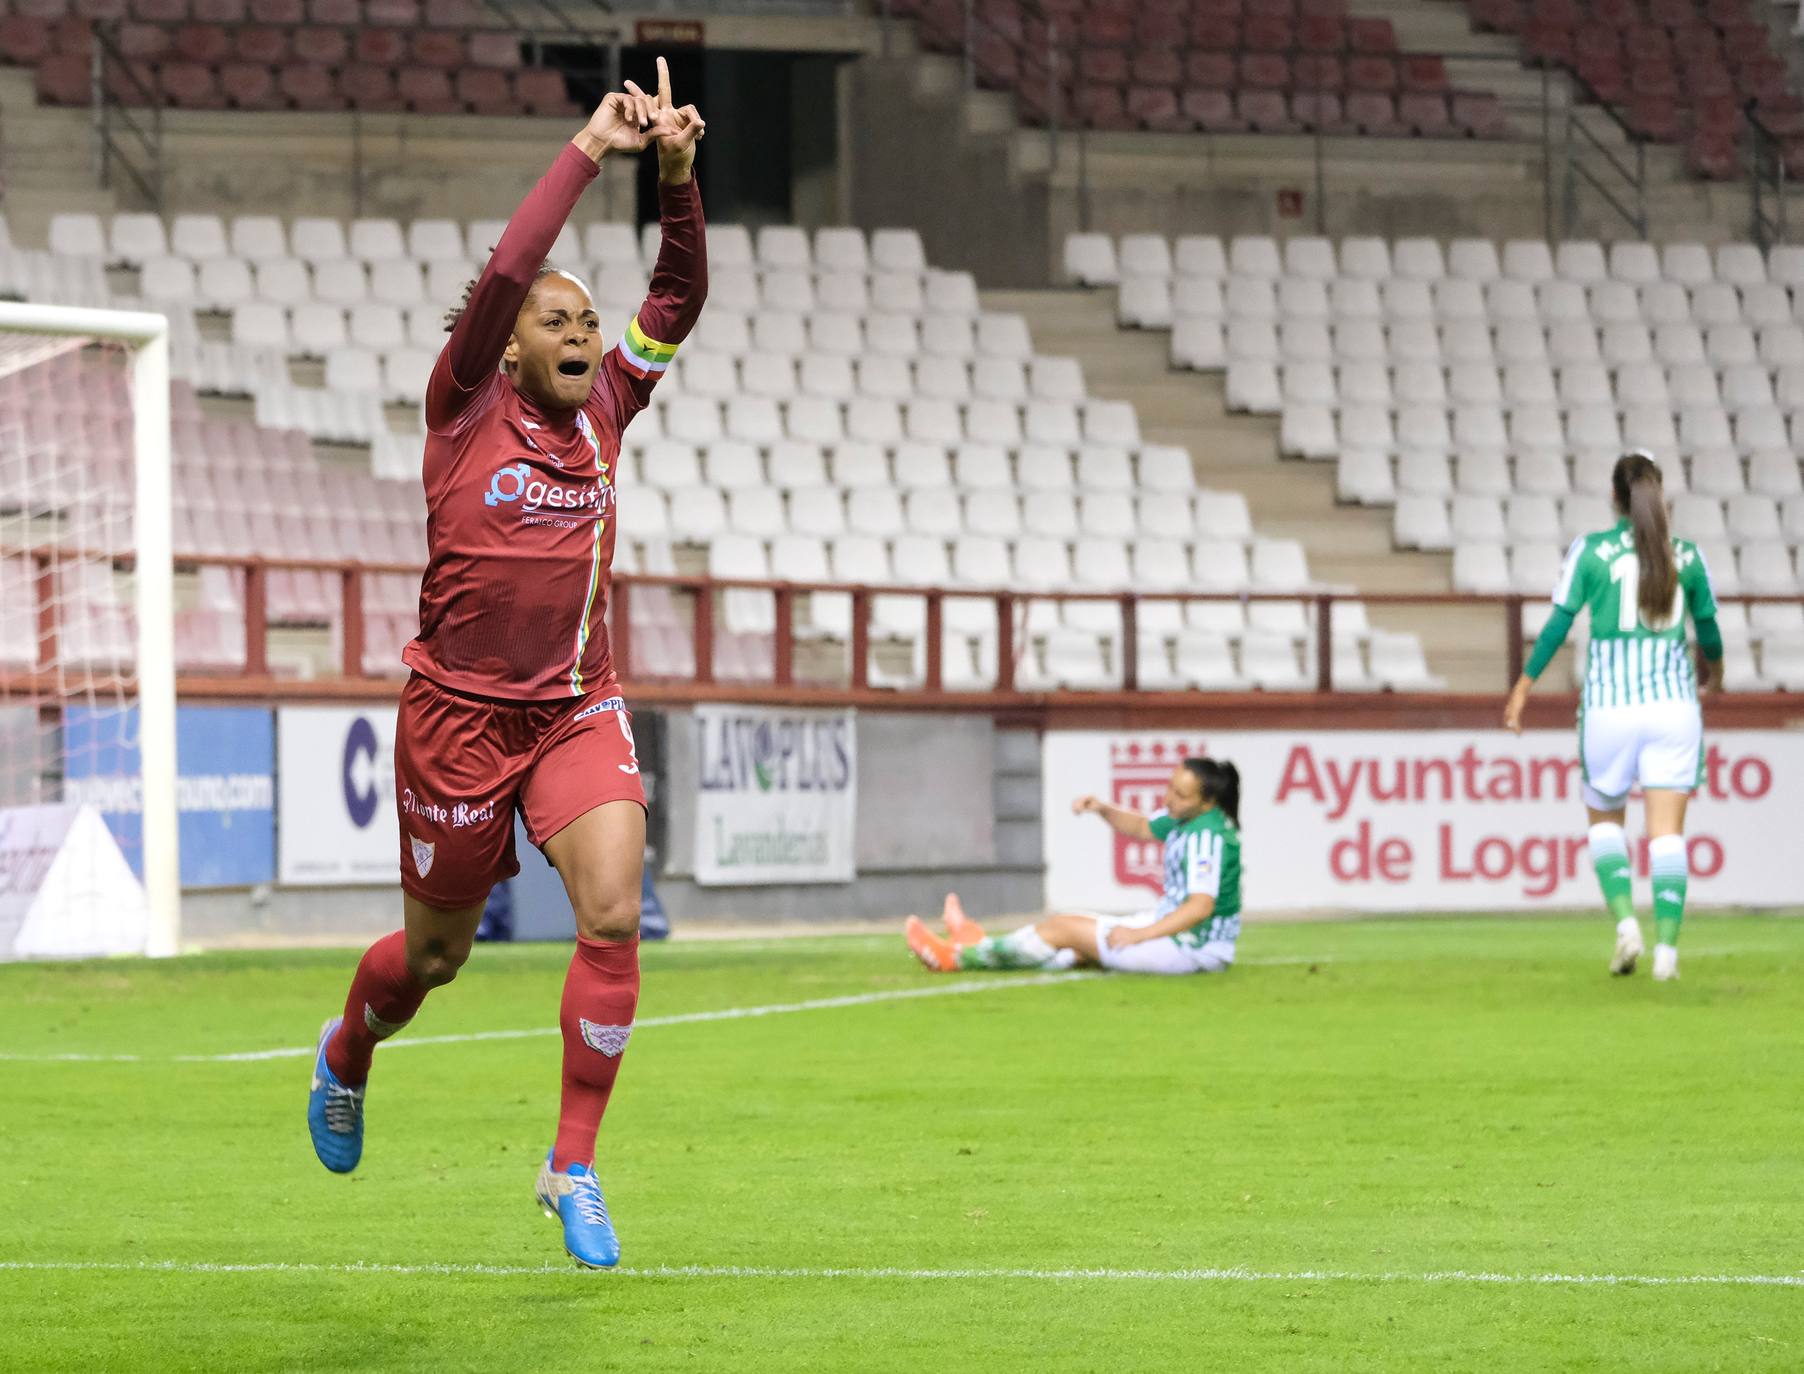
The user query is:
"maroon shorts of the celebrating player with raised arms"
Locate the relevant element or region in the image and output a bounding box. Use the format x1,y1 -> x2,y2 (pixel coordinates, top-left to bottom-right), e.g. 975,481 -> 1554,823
395,673 -> 646,907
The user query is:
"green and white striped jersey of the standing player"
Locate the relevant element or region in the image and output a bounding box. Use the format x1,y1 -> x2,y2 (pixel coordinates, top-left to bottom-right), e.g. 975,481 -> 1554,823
1553,519 -> 1716,707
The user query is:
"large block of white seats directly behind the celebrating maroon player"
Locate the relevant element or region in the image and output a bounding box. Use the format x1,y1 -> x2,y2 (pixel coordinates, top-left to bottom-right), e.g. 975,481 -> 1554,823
0,204 -> 1434,691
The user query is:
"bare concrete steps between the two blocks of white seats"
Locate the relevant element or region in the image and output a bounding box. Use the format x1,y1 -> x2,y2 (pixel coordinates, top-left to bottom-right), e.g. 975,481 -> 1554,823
983,290 -> 1506,691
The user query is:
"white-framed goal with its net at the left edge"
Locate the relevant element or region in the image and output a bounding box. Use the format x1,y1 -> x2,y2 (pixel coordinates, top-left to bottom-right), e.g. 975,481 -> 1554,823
0,301 -> 180,959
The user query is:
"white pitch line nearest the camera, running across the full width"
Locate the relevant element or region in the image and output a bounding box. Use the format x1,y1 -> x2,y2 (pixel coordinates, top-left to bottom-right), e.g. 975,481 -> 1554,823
0,1260 -> 1804,1287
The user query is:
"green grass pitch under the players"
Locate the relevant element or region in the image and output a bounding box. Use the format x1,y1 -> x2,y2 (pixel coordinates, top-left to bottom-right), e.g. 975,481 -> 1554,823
0,916 -> 1804,1374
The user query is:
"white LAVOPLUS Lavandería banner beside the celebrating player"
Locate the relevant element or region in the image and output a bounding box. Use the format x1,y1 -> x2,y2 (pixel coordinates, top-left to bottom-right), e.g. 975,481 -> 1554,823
695,707 -> 859,887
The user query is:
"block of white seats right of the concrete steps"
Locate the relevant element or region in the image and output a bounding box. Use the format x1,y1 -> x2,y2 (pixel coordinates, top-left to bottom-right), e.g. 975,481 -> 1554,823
1064,234 -> 1804,687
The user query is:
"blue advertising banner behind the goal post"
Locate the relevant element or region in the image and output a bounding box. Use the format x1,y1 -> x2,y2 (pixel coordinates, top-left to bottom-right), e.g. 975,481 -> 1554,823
63,707 -> 276,887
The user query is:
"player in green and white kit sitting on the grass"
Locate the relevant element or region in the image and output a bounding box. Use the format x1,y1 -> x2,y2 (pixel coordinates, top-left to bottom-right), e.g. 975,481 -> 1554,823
906,759 -> 1241,974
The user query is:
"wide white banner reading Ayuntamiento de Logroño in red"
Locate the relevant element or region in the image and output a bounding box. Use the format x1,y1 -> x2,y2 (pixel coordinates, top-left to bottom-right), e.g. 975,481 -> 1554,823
1043,728 -> 1804,914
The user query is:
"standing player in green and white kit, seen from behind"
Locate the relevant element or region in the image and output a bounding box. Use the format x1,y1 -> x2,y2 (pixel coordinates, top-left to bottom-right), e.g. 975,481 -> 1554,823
1503,453 -> 1723,981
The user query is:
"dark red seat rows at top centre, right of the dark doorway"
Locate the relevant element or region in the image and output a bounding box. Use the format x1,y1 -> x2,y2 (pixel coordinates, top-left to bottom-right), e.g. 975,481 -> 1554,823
891,0 -> 1506,139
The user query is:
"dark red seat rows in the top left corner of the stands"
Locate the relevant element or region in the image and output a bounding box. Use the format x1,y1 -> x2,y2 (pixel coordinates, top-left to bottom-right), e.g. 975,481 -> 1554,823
0,0 -> 577,115
